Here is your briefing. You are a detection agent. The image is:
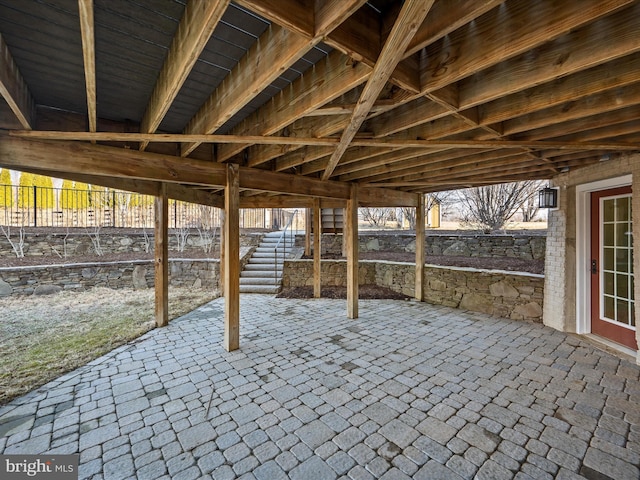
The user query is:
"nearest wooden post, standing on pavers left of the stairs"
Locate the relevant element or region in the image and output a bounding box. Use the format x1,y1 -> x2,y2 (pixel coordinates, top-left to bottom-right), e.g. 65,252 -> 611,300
224,164 -> 240,352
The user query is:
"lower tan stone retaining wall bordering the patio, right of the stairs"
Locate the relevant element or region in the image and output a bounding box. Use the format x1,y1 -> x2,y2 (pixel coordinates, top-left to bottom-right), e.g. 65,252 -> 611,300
283,260 -> 544,322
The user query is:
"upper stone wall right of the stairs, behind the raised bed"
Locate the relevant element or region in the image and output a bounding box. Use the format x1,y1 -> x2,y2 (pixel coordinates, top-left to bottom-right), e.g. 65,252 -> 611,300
316,232 -> 546,260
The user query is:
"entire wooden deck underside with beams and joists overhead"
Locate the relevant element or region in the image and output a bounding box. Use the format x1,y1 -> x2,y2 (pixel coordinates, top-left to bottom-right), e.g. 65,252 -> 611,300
0,0 -> 640,206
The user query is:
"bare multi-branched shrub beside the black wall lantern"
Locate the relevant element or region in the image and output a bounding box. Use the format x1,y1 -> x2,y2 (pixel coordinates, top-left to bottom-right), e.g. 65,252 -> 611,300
460,180 -> 539,230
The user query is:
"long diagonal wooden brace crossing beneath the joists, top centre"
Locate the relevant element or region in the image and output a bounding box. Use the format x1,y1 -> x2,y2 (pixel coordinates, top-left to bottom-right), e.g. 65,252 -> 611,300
322,0 -> 433,180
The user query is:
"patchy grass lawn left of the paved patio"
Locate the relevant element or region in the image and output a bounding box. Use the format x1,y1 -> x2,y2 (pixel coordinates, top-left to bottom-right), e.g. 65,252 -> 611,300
0,287 -> 217,405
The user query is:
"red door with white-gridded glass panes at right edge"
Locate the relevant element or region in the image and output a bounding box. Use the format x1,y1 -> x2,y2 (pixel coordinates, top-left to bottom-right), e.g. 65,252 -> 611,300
591,187 -> 638,350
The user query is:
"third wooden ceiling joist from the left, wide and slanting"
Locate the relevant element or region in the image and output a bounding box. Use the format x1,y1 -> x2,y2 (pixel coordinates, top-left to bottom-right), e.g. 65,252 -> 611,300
139,0 -> 229,150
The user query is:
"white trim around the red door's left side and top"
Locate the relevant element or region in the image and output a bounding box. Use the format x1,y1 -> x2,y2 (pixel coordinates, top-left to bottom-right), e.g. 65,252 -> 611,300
576,175 -> 632,334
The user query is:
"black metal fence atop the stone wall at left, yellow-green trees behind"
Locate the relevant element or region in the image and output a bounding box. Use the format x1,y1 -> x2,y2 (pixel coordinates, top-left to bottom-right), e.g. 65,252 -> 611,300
0,185 -> 304,229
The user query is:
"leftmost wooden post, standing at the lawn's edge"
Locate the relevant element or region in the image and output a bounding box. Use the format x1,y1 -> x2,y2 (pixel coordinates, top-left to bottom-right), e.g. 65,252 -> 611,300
154,183 -> 169,327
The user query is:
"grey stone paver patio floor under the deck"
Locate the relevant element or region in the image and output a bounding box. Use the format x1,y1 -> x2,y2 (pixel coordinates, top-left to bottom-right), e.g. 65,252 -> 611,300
0,295 -> 640,480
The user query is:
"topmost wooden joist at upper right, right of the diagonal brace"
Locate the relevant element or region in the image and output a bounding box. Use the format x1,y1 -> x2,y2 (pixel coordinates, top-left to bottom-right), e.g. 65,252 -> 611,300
420,0 -> 634,93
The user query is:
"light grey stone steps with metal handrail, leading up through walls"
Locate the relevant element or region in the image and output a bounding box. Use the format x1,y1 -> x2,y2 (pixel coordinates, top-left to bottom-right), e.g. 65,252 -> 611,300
240,231 -> 295,293
